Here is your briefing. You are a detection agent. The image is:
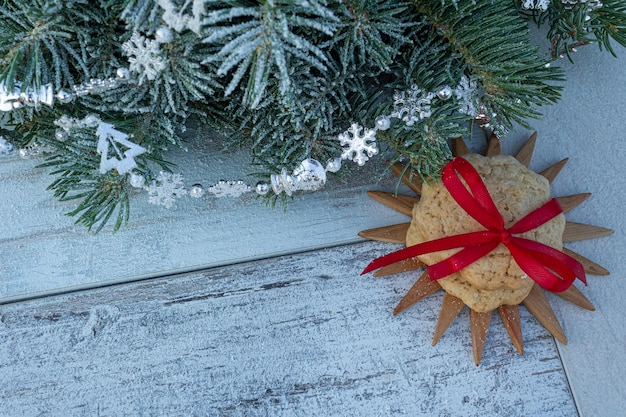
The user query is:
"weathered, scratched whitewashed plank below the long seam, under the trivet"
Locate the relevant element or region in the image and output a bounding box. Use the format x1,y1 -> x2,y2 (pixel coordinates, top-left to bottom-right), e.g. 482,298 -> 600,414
0,242 -> 576,417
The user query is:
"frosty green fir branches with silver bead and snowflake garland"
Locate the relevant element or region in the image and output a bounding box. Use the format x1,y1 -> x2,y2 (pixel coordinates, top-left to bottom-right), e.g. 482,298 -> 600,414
0,0 -> 626,231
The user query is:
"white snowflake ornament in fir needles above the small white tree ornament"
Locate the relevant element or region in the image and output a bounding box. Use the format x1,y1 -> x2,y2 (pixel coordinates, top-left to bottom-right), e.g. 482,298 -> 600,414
122,32 -> 165,84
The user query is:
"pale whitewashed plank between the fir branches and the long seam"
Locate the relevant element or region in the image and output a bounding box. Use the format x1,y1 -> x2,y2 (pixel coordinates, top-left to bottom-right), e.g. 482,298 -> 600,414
0,135 -> 411,304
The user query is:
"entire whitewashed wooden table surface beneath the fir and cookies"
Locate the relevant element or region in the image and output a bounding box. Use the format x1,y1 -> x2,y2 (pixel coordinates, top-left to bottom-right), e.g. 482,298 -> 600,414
0,41 -> 626,417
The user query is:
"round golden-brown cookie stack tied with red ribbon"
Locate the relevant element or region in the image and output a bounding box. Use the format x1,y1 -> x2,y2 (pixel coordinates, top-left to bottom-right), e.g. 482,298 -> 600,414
406,154 -> 565,312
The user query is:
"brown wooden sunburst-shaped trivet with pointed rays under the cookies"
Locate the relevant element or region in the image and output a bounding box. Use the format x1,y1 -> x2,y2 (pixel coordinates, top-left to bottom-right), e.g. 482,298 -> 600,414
359,132 -> 613,365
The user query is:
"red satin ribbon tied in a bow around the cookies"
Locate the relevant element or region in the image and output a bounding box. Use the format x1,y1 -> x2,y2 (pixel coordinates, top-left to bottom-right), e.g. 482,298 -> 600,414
361,158 -> 587,292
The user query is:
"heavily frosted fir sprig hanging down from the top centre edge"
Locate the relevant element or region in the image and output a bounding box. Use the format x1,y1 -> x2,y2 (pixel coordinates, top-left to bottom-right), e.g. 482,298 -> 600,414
203,0 -> 338,108
